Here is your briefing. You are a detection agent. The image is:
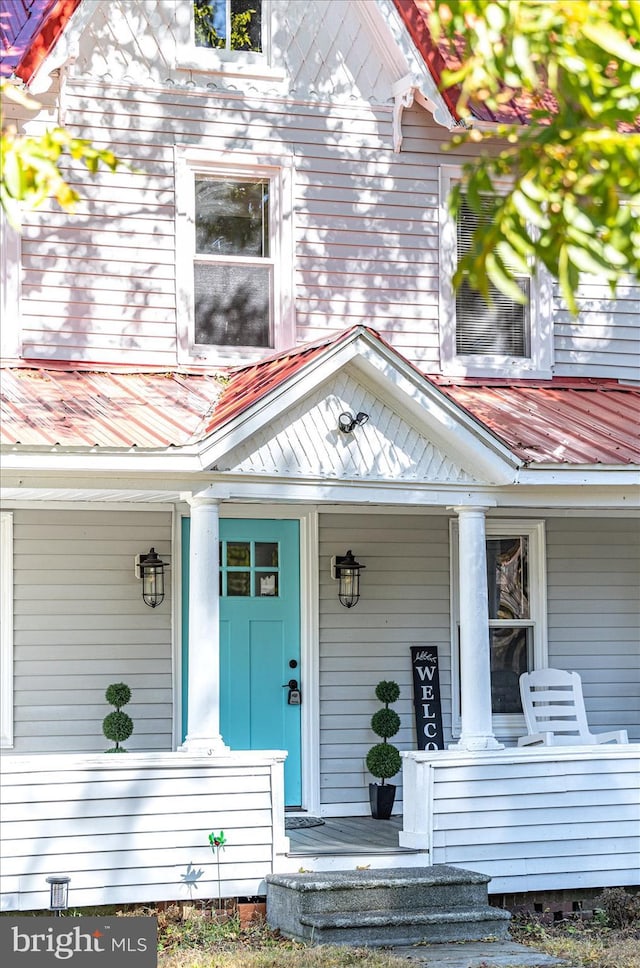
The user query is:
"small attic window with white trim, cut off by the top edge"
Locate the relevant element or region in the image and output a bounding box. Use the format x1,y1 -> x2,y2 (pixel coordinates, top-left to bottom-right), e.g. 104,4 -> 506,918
175,0 -> 285,81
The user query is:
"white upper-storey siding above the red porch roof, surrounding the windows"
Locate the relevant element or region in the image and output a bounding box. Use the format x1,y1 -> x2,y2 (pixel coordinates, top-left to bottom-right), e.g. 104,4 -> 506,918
6,0 -> 640,379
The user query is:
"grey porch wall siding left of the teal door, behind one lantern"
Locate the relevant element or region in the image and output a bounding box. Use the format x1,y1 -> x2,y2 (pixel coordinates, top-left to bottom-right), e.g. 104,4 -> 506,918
13,509 -> 173,753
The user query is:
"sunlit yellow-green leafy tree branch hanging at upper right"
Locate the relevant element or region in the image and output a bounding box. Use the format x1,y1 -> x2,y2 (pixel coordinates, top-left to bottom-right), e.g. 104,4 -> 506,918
430,0 -> 640,315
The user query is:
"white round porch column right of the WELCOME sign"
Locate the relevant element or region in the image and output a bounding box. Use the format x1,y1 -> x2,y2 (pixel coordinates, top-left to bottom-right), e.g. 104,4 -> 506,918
455,507 -> 502,750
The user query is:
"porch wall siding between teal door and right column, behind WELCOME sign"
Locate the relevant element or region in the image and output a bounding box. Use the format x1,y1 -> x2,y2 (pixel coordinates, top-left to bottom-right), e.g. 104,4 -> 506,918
319,514 -> 451,815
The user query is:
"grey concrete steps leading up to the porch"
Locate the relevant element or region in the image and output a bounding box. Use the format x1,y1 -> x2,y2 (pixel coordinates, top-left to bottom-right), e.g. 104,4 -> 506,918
266,865 -> 509,946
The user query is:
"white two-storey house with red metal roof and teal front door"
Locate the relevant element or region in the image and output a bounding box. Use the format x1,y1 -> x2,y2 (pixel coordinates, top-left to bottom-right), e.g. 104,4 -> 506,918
0,0 -> 640,910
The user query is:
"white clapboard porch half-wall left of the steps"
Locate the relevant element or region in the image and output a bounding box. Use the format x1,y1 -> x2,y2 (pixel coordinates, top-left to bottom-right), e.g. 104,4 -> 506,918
0,751 -> 289,911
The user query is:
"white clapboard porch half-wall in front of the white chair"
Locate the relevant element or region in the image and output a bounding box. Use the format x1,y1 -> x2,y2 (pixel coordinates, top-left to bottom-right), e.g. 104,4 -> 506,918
400,744 -> 640,893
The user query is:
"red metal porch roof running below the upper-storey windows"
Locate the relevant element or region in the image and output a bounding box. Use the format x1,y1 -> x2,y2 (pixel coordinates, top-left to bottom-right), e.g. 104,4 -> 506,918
0,327 -> 640,466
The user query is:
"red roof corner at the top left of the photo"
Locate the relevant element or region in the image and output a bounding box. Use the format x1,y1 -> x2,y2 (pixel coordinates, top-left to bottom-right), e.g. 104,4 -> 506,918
0,0 -> 81,83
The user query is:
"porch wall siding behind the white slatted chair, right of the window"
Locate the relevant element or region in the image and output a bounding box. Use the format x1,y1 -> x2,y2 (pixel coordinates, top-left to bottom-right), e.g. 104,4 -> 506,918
547,517 -> 640,741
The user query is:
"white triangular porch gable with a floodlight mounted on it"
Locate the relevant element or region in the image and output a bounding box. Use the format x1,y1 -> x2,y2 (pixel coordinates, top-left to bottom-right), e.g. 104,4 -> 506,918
212,367 -> 478,485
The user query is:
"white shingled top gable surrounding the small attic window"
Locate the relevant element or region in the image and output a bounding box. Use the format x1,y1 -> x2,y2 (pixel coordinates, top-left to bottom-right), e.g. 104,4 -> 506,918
56,0 -> 404,103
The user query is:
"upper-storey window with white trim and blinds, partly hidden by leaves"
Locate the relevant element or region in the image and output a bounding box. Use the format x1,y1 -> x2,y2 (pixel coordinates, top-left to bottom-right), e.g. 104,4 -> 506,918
440,166 -> 553,378
